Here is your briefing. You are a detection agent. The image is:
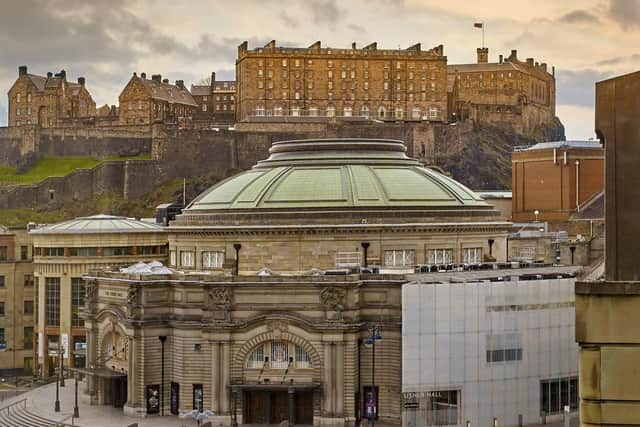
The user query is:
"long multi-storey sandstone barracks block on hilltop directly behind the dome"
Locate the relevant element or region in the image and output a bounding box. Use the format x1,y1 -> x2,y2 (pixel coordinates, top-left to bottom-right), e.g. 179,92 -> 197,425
236,40 -> 447,121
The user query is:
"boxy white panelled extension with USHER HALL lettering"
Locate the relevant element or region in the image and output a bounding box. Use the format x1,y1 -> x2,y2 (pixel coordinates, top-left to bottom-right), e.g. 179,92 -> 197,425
402,267 -> 578,427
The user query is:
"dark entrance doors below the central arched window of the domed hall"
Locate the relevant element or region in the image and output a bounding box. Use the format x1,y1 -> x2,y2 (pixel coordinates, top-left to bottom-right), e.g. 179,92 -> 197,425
244,390 -> 313,425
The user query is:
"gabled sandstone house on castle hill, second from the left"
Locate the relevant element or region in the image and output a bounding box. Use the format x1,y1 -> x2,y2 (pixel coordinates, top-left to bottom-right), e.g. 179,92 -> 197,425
118,73 -> 198,126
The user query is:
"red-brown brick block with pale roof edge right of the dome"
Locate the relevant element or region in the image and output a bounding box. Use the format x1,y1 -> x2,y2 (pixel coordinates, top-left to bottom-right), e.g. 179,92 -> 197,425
511,141 -> 604,222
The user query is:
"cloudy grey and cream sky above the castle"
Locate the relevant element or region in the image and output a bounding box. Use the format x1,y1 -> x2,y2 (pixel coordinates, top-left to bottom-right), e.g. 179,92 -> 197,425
0,0 -> 640,138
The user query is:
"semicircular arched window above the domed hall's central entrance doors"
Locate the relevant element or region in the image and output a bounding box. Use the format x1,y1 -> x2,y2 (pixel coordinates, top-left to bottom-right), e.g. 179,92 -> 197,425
247,341 -> 311,369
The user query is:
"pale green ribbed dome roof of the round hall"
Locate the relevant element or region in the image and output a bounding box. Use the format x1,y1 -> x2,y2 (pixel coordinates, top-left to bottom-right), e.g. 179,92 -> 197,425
185,139 -> 492,215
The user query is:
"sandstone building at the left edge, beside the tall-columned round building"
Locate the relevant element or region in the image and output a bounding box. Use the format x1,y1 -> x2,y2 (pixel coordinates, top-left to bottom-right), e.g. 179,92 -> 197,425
0,226 -> 37,376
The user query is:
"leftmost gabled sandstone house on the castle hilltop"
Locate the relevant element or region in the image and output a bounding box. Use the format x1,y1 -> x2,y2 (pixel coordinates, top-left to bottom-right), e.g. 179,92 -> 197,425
8,65 -> 96,128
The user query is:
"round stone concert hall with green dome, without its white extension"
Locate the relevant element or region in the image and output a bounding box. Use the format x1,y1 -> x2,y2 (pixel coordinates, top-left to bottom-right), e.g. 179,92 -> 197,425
83,139 -> 510,426
